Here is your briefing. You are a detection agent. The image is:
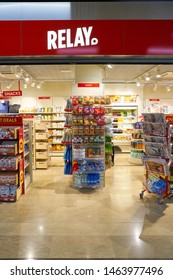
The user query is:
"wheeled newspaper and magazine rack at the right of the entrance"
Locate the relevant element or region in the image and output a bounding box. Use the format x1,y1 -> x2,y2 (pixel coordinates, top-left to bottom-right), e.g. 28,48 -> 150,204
139,113 -> 172,204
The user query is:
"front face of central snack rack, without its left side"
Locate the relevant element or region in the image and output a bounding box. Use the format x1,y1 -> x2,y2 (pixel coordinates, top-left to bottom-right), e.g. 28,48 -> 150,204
69,97 -> 106,189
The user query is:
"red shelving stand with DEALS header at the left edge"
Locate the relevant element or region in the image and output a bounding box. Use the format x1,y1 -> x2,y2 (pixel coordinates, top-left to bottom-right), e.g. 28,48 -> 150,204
0,114 -> 32,201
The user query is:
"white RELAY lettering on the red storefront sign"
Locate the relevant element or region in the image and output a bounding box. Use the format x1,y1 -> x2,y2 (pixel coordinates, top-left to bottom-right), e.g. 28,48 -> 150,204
47,26 -> 98,50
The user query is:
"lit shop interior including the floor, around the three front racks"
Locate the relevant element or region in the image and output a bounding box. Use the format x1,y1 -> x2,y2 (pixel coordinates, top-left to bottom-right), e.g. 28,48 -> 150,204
0,64 -> 173,259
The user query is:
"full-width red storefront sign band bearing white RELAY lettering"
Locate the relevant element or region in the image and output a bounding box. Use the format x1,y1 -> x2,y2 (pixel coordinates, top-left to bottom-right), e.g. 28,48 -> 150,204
0,20 -> 173,56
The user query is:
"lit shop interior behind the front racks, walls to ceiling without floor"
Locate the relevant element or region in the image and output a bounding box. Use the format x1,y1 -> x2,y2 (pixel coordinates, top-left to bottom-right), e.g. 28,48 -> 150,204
0,63 -> 173,197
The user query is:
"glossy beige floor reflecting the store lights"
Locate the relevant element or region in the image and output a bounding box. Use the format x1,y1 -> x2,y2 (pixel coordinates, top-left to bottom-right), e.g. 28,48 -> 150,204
0,154 -> 173,259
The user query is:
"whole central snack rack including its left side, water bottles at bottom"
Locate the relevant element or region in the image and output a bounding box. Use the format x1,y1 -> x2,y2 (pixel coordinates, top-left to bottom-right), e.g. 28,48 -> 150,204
62,96 -> 107,189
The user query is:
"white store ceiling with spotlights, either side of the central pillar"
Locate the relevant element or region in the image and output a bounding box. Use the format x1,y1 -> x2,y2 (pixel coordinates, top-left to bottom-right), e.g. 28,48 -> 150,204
0,64 -> 173,87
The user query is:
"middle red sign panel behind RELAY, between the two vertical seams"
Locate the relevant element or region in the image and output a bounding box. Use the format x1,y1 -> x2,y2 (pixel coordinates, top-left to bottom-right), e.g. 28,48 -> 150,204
22,20 -> 123,55
